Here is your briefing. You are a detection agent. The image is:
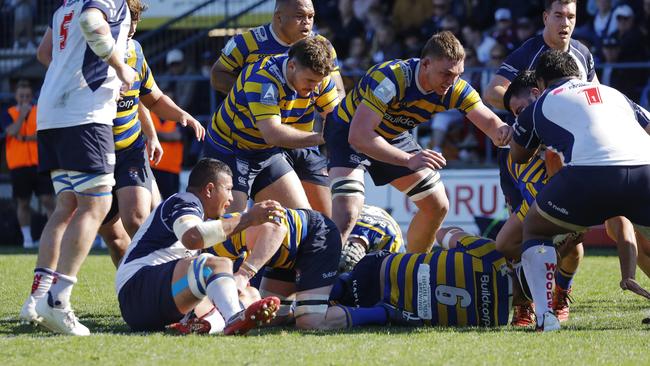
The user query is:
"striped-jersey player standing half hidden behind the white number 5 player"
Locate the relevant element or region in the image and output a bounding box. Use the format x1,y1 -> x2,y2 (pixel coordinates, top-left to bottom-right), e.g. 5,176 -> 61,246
99,0 -> 205,266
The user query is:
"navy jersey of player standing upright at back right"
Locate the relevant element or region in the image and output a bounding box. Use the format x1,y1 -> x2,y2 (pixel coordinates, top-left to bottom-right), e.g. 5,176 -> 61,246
497,34 -> 596,81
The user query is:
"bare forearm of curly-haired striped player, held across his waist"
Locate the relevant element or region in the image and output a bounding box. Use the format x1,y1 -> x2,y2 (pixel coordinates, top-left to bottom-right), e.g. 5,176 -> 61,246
257,116 -> 325,149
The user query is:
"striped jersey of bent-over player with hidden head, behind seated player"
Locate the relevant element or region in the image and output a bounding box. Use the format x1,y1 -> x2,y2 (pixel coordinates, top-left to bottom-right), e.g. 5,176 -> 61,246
208,208 -> 309,269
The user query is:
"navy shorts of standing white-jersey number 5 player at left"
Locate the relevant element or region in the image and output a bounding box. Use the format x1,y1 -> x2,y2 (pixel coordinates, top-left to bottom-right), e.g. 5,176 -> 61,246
37,123 -> 115,174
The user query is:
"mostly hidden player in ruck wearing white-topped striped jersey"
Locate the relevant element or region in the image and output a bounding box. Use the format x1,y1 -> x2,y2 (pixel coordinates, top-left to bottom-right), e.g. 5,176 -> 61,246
339,205 -> 406,272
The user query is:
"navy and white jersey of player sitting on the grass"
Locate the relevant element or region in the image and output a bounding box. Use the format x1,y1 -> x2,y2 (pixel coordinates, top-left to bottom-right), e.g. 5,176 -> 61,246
115,192 -> 203,295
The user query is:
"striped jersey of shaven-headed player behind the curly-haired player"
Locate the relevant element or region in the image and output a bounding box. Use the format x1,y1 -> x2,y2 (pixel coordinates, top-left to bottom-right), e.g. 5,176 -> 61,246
217,23 -> 339,75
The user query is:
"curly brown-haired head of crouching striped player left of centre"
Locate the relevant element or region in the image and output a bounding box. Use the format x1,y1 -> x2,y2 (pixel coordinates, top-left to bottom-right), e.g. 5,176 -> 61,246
286,36 -> 334,97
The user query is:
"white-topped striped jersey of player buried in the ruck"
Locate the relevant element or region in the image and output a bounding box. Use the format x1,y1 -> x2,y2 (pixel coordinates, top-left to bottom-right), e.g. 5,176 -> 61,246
350,205 -> 405,253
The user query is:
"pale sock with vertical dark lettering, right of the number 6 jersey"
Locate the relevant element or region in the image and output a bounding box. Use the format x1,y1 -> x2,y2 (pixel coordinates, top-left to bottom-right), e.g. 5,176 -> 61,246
521,239 -> 557,326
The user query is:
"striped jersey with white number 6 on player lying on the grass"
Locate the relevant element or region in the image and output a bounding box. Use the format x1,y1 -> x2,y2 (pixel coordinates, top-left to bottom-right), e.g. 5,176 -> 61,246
381,236 -> 512,326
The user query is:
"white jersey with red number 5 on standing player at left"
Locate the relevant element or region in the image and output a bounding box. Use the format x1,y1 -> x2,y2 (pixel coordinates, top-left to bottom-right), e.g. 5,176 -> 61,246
37,0 -> 131,131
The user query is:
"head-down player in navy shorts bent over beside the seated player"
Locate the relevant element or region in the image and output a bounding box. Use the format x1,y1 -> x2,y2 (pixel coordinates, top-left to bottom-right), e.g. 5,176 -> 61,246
208,208 -> 345,329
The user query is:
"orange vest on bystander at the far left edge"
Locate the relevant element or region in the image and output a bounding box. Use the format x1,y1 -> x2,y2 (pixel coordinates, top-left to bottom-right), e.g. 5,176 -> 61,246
6,106 -> 38,169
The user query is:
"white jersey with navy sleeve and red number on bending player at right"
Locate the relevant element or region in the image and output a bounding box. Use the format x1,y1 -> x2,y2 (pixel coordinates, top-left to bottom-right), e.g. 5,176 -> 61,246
514,79 -> 650,166
